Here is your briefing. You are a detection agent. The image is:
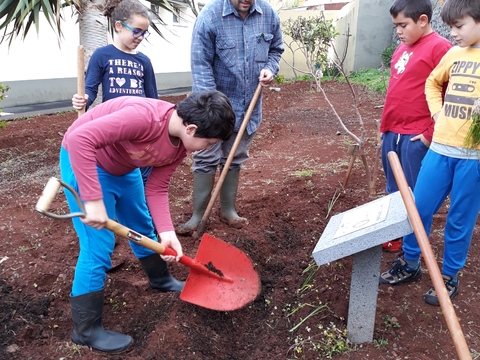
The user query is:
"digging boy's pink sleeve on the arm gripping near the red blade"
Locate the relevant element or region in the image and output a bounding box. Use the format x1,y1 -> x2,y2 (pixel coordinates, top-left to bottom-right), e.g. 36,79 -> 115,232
145,153 -> 186,233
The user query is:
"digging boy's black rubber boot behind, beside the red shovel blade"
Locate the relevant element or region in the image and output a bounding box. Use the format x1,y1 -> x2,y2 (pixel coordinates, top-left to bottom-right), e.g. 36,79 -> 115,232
139,254 -> 185,292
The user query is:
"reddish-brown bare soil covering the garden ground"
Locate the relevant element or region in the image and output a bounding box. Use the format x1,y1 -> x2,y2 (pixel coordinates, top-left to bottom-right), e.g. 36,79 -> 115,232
0,82 -> 480,359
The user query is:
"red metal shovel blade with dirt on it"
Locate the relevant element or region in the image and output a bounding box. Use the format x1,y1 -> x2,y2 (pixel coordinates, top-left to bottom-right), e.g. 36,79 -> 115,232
180,234 -> 260,311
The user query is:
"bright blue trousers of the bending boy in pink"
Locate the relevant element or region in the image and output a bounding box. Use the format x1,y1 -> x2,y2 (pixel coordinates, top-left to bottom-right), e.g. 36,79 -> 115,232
60,147 -> 156,296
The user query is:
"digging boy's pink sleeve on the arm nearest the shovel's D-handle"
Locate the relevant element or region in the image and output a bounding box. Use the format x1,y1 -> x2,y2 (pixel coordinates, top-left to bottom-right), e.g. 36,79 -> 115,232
67,106 -> 151,200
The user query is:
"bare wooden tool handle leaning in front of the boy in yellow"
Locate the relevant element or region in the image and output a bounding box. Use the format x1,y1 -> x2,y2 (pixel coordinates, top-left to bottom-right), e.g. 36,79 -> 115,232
387,151 -> 472,360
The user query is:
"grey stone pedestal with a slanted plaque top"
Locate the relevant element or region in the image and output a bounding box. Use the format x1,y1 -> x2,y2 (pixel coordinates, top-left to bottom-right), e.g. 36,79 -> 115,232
313,192 -> 413,343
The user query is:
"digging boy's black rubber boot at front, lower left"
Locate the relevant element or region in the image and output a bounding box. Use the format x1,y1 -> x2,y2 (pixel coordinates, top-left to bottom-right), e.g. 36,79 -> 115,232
70,289 -> 133,354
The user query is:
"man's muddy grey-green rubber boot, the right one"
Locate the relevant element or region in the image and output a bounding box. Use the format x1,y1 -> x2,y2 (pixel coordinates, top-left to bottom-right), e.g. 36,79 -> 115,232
220,170 -> 247,229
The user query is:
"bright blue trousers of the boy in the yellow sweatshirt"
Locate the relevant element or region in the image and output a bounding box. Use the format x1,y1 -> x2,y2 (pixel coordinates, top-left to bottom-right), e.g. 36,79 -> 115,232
403,150 -> 480,276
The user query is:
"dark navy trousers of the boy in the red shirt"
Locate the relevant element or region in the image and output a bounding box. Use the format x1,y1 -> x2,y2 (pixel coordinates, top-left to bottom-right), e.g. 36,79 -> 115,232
382,131 -> 428,194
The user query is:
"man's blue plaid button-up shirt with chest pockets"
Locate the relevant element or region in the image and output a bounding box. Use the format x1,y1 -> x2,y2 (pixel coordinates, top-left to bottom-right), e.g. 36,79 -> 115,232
191,0 -> 284,135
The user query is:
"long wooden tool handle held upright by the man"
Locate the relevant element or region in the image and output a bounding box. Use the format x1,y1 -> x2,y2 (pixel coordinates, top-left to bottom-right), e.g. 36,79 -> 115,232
193,83 -> 262,240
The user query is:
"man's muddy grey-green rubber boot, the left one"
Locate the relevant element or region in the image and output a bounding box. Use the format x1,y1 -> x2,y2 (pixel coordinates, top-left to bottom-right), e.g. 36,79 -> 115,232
175,172 -> 215,235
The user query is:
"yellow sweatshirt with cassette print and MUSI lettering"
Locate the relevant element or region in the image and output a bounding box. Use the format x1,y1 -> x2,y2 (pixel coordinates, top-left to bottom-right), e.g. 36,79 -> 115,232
425,46 -> 480,149
